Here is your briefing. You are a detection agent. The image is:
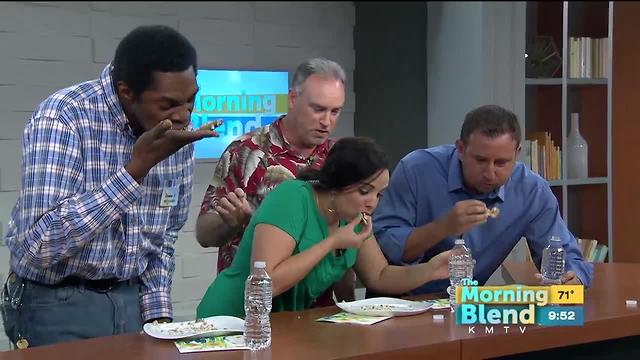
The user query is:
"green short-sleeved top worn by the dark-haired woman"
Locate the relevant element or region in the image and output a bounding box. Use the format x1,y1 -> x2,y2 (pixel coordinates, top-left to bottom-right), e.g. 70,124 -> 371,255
197,180 -> 358,318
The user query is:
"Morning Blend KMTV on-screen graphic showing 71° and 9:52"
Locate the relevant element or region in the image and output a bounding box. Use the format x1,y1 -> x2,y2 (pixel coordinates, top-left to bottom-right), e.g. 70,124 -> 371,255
455,279 -> 584,334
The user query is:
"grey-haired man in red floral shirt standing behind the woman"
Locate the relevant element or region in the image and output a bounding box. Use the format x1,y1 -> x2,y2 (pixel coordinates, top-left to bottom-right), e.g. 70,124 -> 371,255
196,58 -> 355,305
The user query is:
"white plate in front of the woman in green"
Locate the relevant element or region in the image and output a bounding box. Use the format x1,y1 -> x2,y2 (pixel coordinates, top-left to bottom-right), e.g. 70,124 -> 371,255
336,297 -> 432,316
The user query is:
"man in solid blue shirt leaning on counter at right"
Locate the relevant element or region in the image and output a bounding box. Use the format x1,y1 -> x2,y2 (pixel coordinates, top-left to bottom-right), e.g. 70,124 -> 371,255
373,105 -> 593,294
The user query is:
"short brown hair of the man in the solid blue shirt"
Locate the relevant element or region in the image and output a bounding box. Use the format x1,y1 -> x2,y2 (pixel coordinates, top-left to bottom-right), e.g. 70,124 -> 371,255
460,105 -> 522,146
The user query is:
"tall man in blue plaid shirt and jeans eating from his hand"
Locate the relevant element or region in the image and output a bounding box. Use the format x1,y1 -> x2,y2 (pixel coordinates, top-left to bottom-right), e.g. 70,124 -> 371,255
2,26 -> 217,348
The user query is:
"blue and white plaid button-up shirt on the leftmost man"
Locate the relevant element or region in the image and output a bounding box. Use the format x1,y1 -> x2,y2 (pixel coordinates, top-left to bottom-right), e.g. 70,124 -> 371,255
6,65 -> 194,320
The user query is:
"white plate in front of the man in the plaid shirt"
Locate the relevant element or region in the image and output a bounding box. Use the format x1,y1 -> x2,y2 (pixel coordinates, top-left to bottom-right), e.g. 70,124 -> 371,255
142,316 -> 244,340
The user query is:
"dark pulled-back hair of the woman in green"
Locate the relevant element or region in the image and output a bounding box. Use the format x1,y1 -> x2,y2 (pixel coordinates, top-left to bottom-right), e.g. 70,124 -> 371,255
298,136 -> 388,191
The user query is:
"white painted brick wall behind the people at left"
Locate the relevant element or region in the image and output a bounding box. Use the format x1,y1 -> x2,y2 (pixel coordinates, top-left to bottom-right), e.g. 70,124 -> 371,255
0,2 -> 355,349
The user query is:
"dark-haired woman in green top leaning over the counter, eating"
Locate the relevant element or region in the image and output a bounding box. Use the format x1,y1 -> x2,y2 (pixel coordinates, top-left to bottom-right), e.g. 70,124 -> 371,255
197,137 -> 450,318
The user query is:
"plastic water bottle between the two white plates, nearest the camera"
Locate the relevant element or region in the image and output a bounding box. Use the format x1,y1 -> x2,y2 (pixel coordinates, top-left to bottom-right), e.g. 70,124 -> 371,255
244,261 -> 273,350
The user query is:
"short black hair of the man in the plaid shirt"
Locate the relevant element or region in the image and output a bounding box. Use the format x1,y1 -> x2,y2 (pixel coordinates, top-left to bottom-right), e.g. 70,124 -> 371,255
111,25 -> 198,95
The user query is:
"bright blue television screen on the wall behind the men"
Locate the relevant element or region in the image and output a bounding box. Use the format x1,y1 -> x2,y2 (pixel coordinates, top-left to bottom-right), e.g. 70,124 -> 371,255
191,69 -> 289,159
